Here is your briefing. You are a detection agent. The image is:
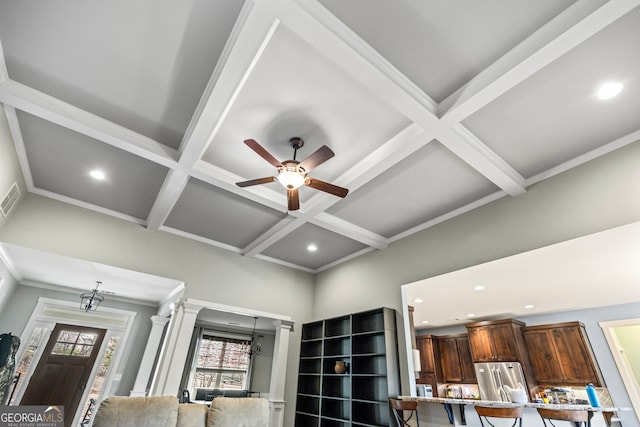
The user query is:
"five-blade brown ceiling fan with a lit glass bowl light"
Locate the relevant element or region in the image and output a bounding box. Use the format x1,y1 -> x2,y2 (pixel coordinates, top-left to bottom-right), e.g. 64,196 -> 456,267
236,137 -> 349,211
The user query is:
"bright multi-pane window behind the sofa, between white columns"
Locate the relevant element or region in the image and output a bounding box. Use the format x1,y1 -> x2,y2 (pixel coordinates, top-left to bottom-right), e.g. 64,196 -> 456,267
190,331 -> 251,390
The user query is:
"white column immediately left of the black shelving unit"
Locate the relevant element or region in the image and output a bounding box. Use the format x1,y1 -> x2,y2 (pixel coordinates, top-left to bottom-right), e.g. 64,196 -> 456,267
269,320 -> 293,427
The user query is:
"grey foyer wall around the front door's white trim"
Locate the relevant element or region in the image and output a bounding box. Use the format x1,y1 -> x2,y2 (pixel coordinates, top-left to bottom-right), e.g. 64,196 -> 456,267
0,285 -> 157,396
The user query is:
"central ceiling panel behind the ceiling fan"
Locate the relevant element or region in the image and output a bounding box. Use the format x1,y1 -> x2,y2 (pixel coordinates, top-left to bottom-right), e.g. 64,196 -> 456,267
203,24 -> 409,180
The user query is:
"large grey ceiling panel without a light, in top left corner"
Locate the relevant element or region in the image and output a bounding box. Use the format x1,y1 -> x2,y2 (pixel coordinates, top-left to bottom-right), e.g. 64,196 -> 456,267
0,0 -> 242,148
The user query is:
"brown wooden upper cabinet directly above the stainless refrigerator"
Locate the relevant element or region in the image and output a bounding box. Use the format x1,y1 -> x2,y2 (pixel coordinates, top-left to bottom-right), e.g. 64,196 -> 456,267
466,319 -> 526,362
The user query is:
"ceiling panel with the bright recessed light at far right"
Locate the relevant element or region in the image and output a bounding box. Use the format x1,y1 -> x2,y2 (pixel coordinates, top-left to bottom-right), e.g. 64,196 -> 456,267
463,8 -> 640,177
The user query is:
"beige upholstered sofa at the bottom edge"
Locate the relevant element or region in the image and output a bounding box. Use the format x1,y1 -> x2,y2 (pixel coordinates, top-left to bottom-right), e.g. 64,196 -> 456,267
93,396 -> 269,427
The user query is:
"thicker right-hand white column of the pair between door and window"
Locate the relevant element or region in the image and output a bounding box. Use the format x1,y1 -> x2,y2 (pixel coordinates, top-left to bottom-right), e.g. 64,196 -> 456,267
149,301 -> 202,396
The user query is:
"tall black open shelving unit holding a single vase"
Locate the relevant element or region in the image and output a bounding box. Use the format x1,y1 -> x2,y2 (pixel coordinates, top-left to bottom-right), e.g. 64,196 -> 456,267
296,308 -> 400,427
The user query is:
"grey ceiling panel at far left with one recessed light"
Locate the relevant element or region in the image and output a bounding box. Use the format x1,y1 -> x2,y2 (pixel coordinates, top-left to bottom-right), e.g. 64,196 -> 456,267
18,113 -> 167,219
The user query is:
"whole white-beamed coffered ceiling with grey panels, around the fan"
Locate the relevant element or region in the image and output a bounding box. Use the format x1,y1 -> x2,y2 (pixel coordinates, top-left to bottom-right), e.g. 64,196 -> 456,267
0,0 -> 640,272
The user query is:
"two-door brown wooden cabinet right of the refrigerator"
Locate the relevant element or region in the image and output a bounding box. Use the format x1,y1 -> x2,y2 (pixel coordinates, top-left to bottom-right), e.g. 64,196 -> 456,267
522,322 -> 604,387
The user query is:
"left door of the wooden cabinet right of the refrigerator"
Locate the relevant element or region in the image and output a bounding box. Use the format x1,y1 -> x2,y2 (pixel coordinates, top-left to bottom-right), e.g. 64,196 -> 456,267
523,330 -> 568,385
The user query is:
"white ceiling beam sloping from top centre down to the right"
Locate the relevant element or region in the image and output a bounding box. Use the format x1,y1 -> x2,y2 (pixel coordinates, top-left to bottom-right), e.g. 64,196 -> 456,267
281,0 -> 524,196
